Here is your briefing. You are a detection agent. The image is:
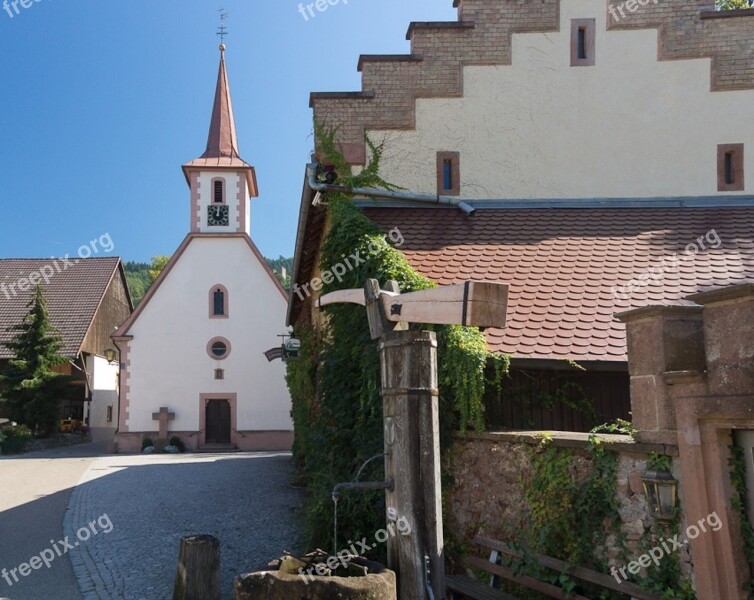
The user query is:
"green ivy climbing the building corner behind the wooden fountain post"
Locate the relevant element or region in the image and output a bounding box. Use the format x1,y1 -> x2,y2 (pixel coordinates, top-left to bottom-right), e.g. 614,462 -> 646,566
287,128 -> 502,560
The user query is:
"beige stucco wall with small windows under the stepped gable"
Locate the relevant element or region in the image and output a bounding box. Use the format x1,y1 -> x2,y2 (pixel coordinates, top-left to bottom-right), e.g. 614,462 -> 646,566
370,0 -> 754,199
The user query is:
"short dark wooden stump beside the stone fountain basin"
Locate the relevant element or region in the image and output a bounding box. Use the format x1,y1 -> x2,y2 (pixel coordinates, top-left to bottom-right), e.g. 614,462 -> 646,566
173,535 -> 220,600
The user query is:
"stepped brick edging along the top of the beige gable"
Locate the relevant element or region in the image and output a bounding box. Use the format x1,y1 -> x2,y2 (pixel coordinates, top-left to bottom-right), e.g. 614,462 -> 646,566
310,0 -> 754,164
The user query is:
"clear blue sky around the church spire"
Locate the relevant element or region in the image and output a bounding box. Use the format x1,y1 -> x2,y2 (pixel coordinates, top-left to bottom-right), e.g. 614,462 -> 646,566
0,0 -> 456,261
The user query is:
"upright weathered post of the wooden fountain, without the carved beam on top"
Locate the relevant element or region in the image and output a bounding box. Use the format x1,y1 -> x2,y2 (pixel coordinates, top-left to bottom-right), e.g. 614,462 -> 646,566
379,330 -> 445,600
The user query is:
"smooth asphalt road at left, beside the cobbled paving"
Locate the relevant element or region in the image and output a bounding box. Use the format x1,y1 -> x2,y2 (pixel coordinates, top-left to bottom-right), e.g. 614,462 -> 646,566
0,444 -> 105,600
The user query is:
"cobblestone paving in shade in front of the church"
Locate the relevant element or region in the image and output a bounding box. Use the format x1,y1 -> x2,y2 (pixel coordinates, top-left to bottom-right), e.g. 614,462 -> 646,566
65,453 -> 301,600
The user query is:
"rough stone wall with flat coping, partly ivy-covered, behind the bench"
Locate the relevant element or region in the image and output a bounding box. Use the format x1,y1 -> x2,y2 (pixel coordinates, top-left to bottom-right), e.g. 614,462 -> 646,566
446,432 -> 692,574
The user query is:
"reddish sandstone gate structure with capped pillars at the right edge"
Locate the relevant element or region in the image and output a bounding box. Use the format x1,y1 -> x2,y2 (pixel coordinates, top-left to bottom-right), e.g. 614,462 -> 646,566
618,284 -> 754,600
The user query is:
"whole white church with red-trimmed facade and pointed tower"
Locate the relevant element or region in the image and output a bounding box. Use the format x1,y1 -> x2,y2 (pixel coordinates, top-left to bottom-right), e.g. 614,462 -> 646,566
113,47 -> 293,452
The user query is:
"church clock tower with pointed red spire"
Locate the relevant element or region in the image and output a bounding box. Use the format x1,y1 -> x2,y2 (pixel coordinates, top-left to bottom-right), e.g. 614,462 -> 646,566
183,44 -> 258,235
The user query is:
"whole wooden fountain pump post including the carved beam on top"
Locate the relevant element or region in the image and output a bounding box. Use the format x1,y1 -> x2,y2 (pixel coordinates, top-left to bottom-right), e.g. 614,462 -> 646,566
318,279 -> 508,600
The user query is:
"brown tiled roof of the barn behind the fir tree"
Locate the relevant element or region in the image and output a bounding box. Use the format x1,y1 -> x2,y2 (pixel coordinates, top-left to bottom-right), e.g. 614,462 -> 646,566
0,257 -> 120,358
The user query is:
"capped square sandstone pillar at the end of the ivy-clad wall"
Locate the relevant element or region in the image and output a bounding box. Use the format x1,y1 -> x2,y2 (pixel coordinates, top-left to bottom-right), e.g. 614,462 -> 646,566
617,306 -> 704,444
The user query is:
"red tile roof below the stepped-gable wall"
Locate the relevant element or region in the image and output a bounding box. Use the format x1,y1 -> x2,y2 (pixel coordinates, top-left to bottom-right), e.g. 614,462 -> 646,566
364,206 -> 754,361
